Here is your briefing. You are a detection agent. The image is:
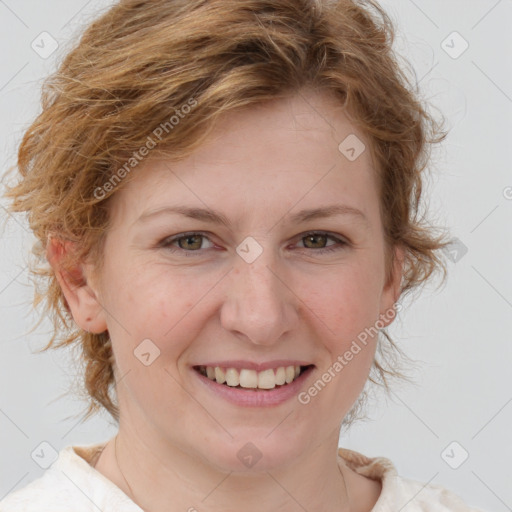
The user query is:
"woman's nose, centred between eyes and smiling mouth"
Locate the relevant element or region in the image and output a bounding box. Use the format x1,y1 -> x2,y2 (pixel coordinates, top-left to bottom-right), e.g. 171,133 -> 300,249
221,249 -> 300,346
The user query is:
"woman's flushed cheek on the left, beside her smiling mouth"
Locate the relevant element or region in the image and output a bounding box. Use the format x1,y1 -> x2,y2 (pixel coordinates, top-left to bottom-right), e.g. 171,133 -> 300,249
100,269 -> 208,417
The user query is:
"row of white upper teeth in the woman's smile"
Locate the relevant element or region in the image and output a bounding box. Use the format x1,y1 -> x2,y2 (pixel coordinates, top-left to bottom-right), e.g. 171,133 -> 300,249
199,366 -> 300,389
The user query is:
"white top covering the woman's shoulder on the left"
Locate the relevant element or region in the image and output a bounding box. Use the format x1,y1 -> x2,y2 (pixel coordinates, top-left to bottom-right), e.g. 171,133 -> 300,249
0,445 -> 141,512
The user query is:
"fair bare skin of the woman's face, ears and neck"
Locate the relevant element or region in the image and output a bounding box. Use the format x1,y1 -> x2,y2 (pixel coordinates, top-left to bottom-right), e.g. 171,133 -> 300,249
48,91 -> 402,512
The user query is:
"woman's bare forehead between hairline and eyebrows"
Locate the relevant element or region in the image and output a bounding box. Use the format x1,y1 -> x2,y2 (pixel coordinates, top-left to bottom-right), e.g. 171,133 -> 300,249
108,92 -> 378,229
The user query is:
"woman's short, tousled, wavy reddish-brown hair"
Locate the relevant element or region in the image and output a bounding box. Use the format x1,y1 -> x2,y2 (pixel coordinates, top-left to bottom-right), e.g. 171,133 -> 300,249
6,0 -> 446,421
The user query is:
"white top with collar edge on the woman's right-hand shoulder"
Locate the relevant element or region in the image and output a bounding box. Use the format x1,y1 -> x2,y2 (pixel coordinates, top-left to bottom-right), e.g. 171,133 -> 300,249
339,448 -> 483,512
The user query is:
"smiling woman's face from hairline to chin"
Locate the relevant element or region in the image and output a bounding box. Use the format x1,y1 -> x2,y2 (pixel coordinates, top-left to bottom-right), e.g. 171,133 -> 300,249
81,93 -> 400,470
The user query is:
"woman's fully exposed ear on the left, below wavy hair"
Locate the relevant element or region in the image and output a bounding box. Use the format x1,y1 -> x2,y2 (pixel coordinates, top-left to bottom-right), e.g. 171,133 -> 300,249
46,237 -> 107,334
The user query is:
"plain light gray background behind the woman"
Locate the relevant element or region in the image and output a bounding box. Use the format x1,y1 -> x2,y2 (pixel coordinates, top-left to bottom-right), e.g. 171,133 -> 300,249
0,0 -> 512,512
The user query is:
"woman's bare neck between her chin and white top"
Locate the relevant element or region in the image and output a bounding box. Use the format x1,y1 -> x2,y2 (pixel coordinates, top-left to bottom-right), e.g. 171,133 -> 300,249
96,422 -> 358,512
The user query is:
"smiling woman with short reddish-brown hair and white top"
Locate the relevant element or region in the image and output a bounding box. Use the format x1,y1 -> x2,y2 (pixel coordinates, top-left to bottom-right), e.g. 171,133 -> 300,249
1,0 -> 484,512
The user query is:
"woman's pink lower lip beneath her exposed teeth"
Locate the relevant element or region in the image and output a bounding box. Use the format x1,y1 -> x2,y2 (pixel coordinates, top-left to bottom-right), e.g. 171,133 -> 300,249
192,366 -> 314,407
